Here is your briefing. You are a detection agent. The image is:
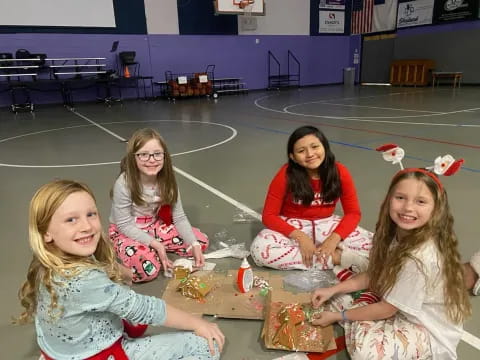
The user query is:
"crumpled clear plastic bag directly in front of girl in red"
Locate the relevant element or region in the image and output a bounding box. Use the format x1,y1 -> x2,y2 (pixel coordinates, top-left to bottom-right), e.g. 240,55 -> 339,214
283,267 -> 337,292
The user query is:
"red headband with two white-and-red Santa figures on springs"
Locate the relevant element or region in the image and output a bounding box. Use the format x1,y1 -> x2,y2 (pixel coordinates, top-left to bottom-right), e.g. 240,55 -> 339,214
375,144 -> 464,191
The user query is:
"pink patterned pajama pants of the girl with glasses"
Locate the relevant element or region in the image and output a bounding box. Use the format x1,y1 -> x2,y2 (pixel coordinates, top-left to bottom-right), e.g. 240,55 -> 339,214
108,220 -> 208,282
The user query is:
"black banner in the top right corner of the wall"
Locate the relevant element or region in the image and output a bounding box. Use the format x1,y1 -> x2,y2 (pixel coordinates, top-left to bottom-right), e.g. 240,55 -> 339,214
433,0 -> 478,24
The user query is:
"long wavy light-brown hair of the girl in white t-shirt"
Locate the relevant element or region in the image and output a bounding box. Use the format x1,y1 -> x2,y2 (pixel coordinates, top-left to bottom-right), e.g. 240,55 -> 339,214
368,170 -> 472,324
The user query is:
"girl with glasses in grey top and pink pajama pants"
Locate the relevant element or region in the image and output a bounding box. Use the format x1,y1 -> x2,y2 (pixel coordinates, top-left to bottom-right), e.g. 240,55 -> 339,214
108,128 -> 208,282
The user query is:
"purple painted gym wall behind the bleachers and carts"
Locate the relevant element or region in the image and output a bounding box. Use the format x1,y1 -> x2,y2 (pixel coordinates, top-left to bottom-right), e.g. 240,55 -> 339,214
0,33 -> 352,106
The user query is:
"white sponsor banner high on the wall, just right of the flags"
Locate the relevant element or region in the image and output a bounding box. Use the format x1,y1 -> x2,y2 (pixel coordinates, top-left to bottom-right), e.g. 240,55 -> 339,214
397,0 -> 434,28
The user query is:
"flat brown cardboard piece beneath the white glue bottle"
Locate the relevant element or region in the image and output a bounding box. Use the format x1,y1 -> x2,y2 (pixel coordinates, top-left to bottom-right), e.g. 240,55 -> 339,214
162,270 -> 283,320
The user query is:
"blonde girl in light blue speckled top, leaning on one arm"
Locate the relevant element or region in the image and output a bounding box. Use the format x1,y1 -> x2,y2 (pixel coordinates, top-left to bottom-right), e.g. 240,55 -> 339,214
17,180 -> 224,360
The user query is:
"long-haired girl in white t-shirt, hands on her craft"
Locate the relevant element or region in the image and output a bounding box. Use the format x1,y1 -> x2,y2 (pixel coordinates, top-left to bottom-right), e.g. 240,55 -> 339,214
312,168 -> 471,360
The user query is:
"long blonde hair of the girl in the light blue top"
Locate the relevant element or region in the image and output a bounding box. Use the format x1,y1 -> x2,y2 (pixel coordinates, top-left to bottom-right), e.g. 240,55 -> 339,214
14,180 -> 121,324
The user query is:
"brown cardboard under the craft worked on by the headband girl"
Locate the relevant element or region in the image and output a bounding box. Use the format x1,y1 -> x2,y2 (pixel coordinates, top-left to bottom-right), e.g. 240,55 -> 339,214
262,288 -> 337,352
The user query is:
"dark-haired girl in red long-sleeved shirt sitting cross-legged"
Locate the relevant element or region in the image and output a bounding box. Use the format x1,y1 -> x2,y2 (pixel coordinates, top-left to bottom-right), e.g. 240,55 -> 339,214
251,126 -> 373,271
